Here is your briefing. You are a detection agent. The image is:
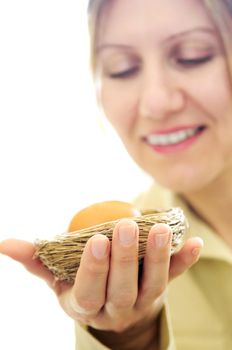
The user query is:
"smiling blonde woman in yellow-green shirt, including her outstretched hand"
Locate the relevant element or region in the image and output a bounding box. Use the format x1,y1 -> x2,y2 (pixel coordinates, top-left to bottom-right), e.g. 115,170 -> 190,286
0,0 -> 232,350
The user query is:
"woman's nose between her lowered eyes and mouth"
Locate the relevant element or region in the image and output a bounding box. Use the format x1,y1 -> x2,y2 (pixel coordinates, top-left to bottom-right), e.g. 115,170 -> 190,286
139,69 -> 185,120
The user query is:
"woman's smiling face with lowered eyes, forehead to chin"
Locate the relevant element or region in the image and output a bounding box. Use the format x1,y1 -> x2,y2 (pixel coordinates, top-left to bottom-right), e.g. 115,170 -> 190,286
96,0 -> 232,193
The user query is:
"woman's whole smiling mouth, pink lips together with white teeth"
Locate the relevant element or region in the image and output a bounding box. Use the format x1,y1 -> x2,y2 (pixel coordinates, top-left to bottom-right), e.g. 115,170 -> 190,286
144,125 -> 206,152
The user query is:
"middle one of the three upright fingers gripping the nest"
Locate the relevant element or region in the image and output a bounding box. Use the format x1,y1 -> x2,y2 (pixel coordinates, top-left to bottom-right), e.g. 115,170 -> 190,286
106,219 -> 138,316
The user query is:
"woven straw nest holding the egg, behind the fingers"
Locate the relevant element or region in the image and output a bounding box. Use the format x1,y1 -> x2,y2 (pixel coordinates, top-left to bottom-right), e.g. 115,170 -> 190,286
34,208 -> 187,283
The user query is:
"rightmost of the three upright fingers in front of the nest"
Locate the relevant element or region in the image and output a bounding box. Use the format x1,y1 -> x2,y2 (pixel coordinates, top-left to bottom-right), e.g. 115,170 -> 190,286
136,224 -> 172,308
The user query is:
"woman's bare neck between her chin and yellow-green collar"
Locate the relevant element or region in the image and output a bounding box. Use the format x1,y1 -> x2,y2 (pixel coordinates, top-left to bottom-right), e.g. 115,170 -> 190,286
183,176 -> 232,247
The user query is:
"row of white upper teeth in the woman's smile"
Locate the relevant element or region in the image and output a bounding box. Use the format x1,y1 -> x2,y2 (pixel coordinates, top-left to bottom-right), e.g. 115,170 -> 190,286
147,128 -> 198,146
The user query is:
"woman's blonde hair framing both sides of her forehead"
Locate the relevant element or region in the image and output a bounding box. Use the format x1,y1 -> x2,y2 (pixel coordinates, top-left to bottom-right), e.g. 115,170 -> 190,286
88,0 -> 232,76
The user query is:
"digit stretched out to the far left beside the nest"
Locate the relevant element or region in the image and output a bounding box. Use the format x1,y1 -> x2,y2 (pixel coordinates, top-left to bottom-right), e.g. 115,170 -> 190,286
0,239 -> 55,288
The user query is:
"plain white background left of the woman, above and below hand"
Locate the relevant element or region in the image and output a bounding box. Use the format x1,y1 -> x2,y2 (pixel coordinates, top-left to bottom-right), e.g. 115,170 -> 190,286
0,0 -> 149,350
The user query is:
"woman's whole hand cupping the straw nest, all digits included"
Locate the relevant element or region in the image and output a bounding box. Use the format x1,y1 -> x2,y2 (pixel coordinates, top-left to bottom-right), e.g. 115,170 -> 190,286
0,219 -> 202,344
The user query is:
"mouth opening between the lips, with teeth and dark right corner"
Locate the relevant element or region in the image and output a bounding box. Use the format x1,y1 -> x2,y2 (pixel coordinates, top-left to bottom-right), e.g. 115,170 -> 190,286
145,125 -> 206,147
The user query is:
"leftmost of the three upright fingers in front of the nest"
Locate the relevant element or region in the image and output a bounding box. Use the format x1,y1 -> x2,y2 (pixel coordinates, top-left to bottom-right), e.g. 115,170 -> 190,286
61,234 -> 110,319
